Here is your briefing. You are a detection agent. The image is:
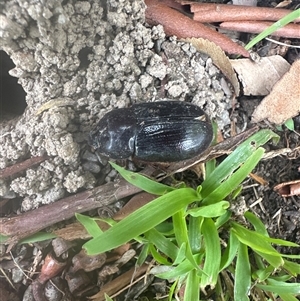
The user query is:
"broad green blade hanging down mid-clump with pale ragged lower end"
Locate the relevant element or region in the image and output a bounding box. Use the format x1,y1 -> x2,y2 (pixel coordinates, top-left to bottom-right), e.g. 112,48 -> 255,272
200,218 -> 221,289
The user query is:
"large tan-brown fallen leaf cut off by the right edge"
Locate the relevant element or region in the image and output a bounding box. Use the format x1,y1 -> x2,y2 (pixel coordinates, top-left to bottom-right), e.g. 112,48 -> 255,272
252,60 -> 300,124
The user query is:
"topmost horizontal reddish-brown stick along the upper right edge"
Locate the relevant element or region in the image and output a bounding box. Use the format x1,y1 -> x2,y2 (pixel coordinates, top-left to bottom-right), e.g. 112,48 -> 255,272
181,1 -> 300,22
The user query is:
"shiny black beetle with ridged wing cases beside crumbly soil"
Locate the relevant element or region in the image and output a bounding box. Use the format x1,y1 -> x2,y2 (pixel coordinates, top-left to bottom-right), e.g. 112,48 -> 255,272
89,101 -> 213,162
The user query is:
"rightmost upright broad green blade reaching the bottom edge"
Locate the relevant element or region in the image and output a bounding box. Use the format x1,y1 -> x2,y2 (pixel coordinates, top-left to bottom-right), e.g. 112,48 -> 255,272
234,243 -> 251,301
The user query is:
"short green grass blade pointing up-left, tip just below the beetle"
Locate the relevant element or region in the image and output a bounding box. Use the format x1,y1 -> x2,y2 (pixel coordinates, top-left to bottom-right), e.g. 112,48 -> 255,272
109,162 -> 175,195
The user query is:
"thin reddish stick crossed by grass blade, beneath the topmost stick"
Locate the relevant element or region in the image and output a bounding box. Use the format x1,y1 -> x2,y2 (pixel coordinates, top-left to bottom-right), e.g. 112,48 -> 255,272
220,21 -> 300,38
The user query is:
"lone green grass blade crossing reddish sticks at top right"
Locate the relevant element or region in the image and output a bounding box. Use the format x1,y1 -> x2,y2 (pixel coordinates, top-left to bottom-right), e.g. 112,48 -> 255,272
245,8 -> 300,50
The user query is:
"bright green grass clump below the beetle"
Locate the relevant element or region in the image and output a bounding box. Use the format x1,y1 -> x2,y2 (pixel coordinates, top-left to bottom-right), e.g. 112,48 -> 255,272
78,130 -> 300,301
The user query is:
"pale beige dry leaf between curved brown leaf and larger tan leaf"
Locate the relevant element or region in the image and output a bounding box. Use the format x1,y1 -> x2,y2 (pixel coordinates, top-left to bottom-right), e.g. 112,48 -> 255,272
231,55 -> 290,95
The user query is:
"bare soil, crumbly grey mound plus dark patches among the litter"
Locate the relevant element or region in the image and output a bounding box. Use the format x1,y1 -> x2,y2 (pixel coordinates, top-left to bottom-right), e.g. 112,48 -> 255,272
0,0 -> 300,300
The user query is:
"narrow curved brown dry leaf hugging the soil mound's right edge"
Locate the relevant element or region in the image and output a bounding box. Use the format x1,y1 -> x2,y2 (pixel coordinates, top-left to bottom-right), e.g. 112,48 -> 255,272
184,38 -> 240,96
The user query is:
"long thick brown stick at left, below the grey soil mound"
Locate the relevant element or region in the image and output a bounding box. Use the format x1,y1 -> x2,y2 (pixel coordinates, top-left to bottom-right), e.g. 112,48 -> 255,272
0,179 -> 140,251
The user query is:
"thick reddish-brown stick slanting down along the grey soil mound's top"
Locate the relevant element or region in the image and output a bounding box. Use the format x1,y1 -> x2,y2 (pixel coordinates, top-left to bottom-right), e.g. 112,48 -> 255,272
145,0 -> 249,57
